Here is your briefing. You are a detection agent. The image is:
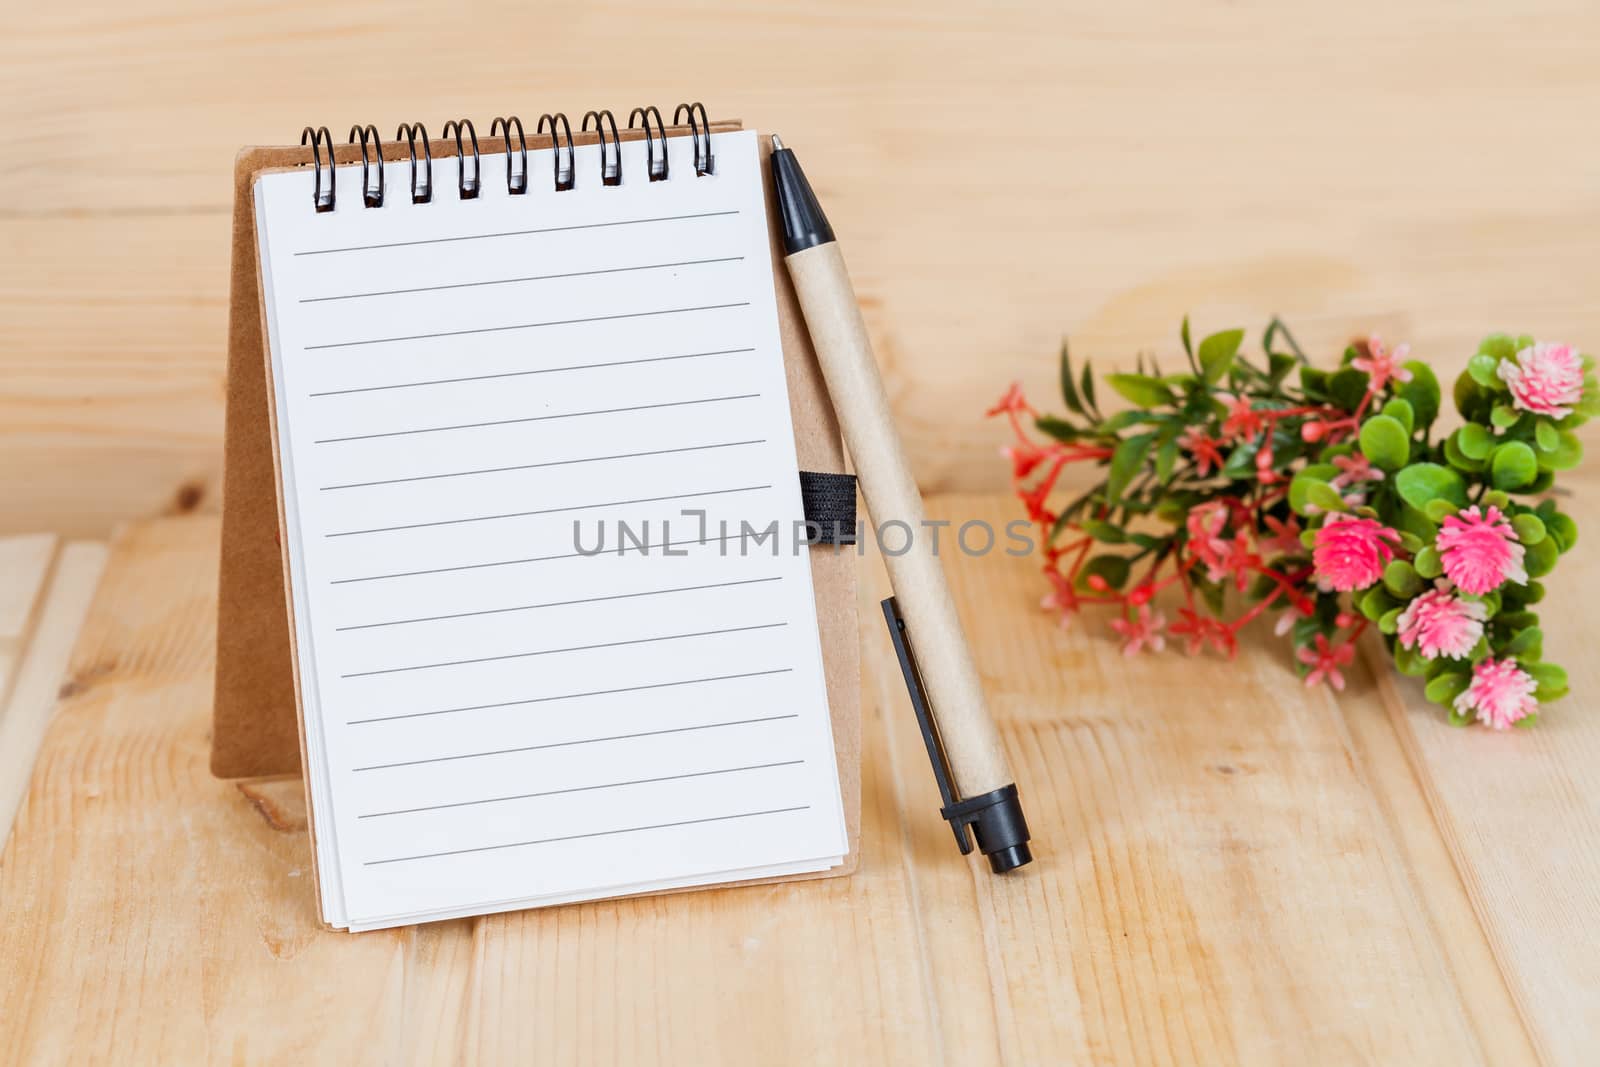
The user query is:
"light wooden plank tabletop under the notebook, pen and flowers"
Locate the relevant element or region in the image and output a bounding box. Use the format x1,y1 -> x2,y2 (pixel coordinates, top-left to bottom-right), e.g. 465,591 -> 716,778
0,489 -> 1600,1067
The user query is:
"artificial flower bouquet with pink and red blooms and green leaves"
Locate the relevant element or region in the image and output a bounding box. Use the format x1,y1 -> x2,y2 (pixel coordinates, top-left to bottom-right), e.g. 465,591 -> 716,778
989,320 -> 1600,729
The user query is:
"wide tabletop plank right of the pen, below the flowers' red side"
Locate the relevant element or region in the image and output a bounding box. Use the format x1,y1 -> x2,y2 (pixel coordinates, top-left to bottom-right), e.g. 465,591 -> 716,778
869,496 -> 1490,1064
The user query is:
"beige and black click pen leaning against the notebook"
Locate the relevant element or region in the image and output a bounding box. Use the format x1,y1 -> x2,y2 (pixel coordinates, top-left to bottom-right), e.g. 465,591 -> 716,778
771,136 -> 1032,873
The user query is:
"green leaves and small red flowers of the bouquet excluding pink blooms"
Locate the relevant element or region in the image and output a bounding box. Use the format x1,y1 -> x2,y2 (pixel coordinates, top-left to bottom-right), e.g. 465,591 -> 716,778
1000,318 -> 1600,725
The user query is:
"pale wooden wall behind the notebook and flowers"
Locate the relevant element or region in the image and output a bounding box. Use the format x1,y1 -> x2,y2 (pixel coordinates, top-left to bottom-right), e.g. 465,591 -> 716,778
0,0 -> 1600,536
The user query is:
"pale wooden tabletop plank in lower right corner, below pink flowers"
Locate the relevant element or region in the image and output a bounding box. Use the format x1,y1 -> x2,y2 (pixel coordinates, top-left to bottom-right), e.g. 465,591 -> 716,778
1366,470 -> 1600,1064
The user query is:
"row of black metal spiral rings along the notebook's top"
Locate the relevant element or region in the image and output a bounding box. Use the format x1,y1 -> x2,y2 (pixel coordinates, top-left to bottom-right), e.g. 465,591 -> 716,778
301,101 -> 717,213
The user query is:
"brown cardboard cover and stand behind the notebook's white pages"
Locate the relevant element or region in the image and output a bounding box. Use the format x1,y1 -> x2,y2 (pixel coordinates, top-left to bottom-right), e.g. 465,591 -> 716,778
211,122 -> 861,881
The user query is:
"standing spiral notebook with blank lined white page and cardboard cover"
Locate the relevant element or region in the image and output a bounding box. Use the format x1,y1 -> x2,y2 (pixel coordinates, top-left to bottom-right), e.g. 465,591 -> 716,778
214,109 -> 856,929
